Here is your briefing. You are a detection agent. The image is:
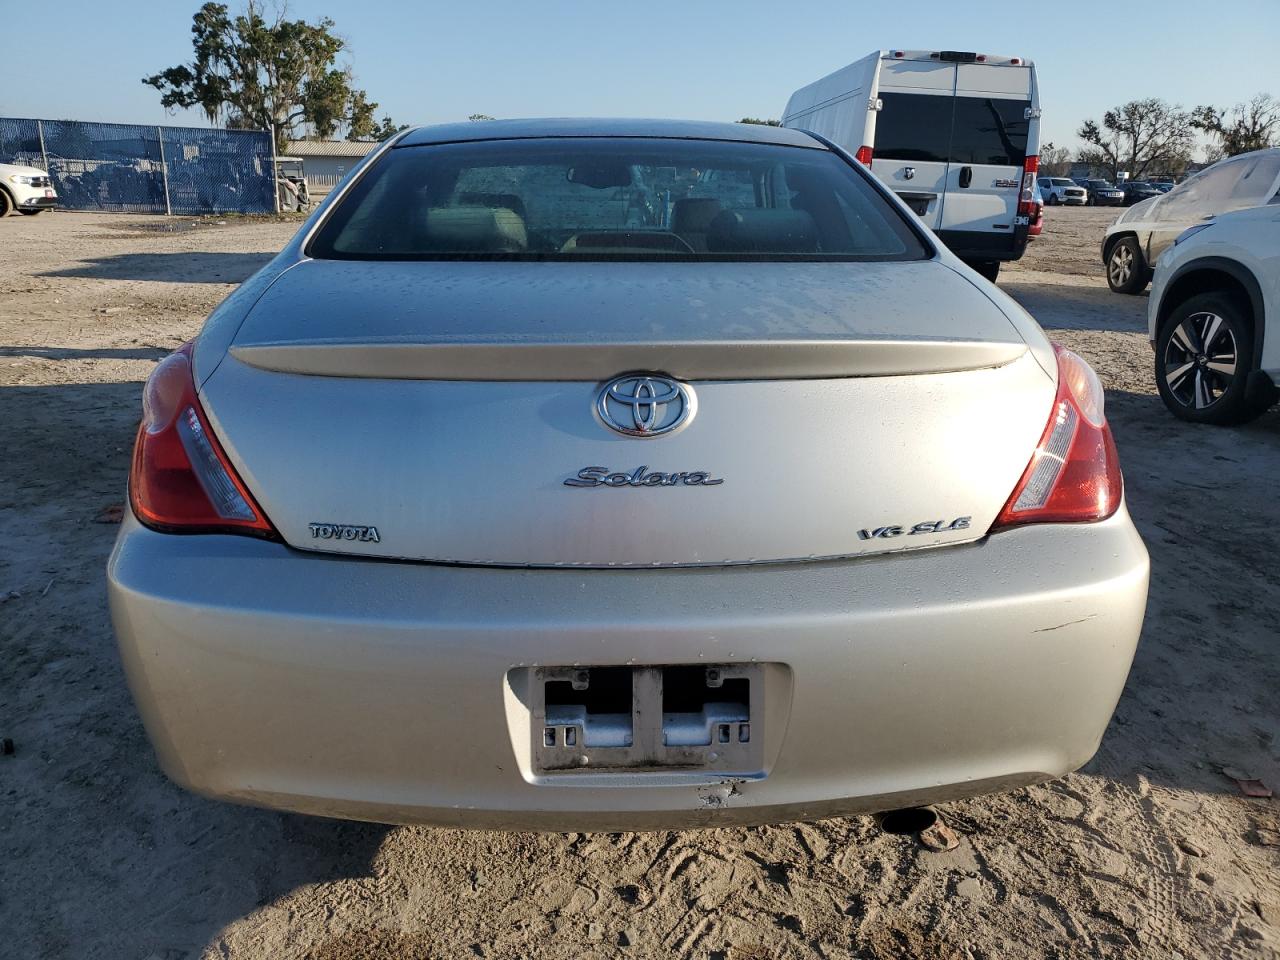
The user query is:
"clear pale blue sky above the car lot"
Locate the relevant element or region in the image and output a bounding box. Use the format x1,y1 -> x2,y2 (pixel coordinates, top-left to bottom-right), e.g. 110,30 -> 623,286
0,0 -> 1280,154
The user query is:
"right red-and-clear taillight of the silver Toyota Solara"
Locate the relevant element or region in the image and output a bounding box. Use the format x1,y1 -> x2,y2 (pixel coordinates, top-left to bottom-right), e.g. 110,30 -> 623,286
991,344 -> 1124,532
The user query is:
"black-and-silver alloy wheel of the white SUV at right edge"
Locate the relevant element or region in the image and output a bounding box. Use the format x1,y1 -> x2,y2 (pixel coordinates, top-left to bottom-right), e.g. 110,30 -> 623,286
1156,293 -> 1275,425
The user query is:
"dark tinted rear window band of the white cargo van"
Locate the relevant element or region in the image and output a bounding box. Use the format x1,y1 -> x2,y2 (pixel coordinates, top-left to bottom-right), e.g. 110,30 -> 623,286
876,92 -> 1032,166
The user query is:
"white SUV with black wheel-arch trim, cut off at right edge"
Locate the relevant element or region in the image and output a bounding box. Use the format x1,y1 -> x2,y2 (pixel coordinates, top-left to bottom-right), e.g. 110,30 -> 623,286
1147,198 -> 1280,424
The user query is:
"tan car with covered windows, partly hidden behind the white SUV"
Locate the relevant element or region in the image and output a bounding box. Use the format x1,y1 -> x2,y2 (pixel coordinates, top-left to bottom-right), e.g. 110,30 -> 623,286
1102,147 -> 1280,293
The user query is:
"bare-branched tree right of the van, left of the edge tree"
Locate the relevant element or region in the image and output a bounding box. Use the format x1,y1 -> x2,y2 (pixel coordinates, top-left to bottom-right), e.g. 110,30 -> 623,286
1078,97 -> 1194,179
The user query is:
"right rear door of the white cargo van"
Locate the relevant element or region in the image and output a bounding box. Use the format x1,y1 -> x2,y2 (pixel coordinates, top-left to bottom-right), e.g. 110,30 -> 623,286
940,63 -> 1038,256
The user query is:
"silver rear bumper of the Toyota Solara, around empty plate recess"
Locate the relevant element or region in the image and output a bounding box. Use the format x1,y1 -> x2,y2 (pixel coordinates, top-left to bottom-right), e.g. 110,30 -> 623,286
108,508 -> 1148,829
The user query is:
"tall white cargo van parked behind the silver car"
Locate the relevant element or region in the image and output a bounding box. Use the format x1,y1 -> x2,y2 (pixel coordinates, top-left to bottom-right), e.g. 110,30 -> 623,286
782,50 -> 1039,280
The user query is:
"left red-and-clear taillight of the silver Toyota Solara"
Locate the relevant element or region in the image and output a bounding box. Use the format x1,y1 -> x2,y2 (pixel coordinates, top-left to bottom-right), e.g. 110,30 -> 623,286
129,343 -> 276,538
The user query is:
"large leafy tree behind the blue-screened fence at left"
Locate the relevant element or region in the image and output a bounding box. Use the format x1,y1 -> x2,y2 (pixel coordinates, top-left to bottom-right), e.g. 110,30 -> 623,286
142,0 -> 393,151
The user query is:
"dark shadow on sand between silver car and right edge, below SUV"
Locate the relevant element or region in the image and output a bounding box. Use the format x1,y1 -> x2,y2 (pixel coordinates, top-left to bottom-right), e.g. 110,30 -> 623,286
1085,390 -> 1280,794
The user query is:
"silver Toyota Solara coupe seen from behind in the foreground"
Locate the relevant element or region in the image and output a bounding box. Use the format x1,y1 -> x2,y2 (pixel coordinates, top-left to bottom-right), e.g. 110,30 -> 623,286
108,120 -> 1148,829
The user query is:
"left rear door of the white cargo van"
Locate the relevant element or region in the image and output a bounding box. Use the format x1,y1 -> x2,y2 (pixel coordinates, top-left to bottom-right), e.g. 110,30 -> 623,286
872,58 -> 956,229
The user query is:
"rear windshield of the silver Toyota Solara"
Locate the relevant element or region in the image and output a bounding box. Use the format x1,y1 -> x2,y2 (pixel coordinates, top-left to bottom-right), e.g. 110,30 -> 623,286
307,138 -> 929,261
